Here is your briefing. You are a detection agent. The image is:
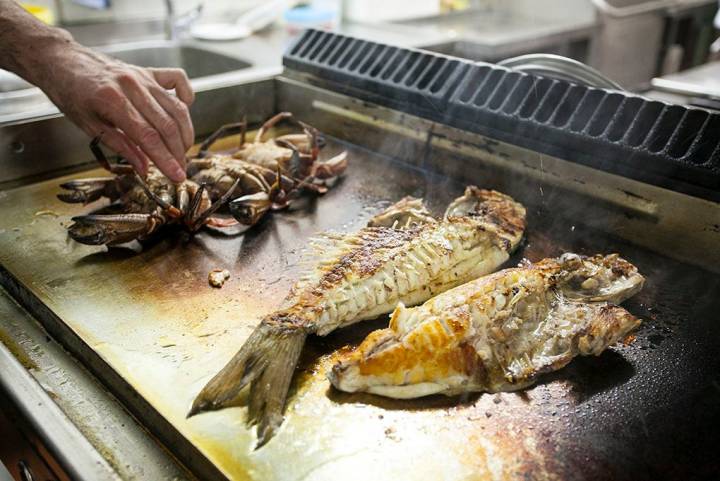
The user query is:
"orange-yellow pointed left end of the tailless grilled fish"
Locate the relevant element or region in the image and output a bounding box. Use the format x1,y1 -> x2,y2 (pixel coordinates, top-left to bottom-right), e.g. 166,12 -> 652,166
328,304 -> 486,399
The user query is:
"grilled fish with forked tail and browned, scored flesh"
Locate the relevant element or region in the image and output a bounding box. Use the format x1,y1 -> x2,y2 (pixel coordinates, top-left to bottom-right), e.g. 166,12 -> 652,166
189,187 -> 525,446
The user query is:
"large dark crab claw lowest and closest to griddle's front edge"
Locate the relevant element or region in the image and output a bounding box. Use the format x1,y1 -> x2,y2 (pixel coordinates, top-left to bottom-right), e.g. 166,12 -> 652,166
68,214 -> 160,245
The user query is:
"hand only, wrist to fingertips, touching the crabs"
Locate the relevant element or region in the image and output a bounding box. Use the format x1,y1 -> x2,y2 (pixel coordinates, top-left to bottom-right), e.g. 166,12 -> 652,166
32,42 -> 195,182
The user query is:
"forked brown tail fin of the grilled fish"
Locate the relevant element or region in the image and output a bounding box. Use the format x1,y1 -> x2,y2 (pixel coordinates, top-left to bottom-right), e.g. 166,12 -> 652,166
188,318 -> 307,448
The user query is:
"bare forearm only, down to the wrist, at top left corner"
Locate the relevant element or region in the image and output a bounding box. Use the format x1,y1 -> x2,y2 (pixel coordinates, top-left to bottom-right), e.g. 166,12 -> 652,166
0,0 -> 74,84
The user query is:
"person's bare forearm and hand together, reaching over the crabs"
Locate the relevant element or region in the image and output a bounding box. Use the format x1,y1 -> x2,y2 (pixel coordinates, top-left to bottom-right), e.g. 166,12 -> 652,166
0,0 -> 195,182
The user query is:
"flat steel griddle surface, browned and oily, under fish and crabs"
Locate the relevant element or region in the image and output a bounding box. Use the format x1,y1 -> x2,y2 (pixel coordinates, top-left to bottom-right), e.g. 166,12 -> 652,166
0,132 -> 720,480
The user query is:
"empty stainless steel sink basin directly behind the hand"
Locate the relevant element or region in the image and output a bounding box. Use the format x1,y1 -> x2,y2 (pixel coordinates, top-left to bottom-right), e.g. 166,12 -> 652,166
102,43 -> 251,79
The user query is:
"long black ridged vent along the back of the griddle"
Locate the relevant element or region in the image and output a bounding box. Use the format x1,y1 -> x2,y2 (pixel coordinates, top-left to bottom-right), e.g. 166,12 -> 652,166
283,30 -> 720,201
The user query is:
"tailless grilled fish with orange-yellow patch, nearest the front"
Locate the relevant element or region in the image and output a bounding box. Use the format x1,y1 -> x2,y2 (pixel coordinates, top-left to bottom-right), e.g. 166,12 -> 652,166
328,254 -> 644,399
